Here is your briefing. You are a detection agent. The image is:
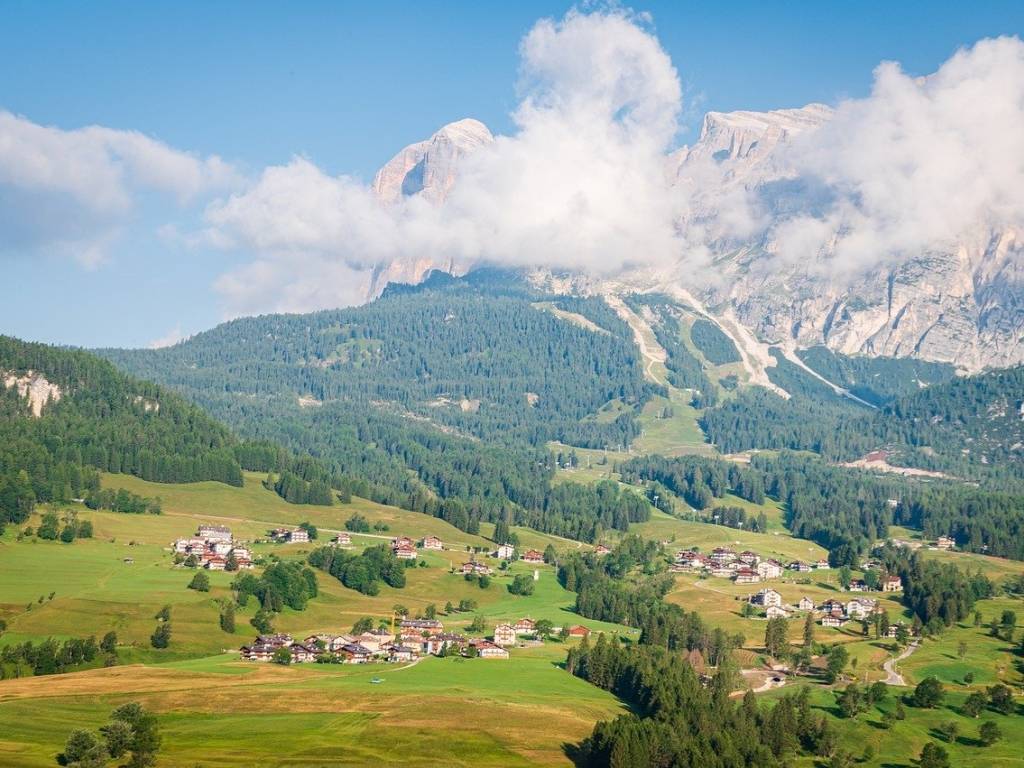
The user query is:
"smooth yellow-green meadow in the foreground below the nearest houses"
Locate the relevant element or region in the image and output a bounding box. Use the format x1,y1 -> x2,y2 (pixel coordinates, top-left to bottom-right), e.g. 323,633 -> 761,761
0,647 -> 622,768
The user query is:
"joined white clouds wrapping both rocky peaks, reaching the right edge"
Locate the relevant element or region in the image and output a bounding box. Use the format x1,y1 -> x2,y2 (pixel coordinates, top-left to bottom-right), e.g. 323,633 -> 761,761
205,15 -> 1024,314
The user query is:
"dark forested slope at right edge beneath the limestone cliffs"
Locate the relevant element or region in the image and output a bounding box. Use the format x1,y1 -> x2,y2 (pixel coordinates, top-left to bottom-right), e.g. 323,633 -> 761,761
701,353 -> 1024,489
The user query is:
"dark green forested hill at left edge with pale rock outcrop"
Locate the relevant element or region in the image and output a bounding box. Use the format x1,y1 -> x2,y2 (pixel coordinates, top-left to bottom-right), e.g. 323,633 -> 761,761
0,337 -> 242,522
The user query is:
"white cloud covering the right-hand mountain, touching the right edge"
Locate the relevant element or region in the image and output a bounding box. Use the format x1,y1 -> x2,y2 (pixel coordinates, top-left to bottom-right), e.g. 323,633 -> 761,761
770,38 -> 1024,273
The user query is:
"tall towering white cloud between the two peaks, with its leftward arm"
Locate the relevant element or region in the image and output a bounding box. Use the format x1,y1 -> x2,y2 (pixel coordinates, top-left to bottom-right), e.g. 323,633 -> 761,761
207,10 -> 682,313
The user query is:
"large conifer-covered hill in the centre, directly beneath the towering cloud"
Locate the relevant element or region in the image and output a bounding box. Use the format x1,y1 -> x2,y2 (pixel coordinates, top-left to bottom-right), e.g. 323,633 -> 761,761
101,272 -> 659,540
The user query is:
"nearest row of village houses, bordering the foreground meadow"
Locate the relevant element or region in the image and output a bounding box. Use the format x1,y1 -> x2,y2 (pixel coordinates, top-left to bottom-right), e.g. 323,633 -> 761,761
242,618 -> 590,664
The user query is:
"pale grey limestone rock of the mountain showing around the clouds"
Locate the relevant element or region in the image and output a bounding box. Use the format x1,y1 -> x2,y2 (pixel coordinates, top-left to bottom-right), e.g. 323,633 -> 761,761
367,104 -> 1024,372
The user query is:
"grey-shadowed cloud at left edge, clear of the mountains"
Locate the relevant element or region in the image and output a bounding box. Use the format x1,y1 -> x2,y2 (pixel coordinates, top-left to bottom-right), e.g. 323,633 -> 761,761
0,112 -> 238,265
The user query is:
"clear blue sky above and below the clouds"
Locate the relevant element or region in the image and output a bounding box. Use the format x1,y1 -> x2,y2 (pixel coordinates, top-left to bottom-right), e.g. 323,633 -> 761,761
0,2 -> 1024,346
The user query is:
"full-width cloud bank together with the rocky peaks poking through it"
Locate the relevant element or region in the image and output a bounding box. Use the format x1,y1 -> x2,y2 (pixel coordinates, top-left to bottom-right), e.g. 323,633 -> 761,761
0,4 -> 1024,323
